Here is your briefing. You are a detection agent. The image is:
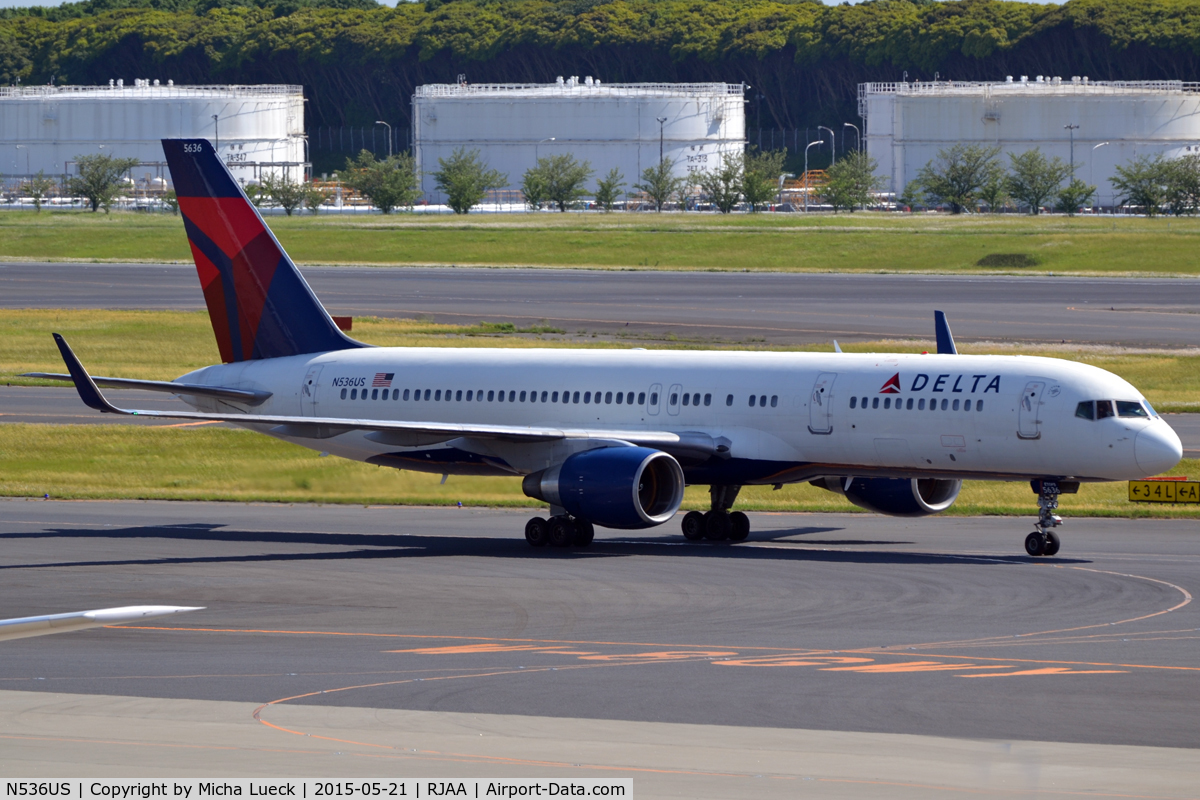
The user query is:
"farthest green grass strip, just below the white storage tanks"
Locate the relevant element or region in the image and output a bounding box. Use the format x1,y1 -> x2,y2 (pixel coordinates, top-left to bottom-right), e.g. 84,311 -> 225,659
0,211 -> 1200,276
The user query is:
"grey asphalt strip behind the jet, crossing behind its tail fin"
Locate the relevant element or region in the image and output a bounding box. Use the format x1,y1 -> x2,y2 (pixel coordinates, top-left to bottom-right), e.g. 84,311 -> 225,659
0,263 -> 1200,348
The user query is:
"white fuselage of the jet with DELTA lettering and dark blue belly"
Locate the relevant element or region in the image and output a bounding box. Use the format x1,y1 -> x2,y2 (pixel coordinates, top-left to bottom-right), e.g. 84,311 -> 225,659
181,348 -> 1182,485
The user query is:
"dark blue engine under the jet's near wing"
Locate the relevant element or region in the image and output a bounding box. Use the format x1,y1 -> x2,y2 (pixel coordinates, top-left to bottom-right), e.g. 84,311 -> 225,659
521,447 -> 684,529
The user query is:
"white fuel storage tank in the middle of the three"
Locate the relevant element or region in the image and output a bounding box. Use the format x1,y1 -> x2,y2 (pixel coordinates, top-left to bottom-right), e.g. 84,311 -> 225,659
413,77 -> 745,203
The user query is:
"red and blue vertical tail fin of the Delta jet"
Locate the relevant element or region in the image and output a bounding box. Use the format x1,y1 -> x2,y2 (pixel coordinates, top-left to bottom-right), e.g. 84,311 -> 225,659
162,139 -> 366,363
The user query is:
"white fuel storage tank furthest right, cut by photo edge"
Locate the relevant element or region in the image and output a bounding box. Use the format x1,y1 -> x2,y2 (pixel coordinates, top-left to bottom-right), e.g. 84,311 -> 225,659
858,76 -> 1200,206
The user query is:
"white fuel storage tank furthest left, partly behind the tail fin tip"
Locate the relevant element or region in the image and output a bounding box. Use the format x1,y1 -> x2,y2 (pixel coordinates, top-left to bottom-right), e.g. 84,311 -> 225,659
0,79 -> 307,182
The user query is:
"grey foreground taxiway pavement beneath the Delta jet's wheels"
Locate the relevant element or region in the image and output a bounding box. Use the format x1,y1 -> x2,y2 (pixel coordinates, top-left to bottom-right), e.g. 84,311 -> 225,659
0,500 -> 1200,796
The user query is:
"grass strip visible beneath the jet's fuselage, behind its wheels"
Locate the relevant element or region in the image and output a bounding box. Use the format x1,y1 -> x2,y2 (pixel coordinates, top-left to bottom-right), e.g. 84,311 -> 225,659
0,425 -> 1200,518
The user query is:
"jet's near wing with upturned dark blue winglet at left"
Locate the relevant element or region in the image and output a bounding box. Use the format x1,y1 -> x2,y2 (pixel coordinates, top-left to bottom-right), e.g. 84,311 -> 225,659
54,333 -> 720,455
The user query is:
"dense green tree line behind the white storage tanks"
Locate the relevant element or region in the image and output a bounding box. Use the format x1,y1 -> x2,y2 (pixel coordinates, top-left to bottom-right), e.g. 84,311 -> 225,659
0,0 -> 1200,128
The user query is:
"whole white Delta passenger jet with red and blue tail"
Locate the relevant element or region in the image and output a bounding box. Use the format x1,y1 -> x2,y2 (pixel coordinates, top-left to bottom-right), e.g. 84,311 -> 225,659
32,139 -> 1182,555
